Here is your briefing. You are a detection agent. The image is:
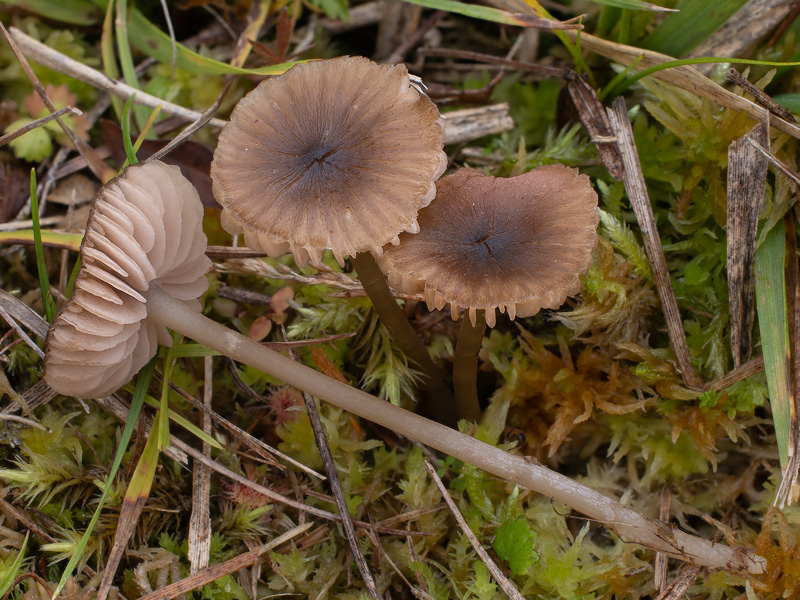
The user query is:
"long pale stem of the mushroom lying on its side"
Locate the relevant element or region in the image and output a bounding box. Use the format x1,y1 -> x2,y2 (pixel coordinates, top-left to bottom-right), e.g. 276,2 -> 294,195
144,285 -> 766,574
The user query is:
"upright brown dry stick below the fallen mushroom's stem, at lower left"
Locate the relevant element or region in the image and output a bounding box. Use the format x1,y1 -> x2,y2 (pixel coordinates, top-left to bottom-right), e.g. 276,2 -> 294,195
187,356 -> 214,575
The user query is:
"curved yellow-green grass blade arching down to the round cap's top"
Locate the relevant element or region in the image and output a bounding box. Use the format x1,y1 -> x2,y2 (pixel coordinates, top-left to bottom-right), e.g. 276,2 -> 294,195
128,8 -> 307,75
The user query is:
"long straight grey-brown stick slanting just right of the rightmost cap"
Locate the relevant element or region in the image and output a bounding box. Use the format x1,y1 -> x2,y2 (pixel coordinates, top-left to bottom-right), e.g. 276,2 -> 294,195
608,98 -> 703,389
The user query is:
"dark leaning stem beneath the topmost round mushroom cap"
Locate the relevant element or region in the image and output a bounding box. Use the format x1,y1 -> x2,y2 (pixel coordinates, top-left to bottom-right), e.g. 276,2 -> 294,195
350,252 -> 456,427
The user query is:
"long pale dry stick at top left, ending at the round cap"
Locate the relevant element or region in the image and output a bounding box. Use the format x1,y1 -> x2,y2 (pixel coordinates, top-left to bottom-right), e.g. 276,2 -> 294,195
11,27 -> 225,129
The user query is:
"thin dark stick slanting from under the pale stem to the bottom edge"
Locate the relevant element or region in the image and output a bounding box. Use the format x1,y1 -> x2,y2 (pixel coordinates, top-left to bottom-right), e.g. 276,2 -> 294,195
284,340 -> 380,599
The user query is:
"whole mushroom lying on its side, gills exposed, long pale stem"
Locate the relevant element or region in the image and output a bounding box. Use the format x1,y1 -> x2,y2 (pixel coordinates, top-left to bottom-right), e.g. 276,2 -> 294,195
40,162 -> 765,574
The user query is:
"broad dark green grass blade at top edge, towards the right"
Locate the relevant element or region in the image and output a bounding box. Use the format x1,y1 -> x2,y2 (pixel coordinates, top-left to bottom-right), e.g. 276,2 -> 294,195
644,0 -> 747,56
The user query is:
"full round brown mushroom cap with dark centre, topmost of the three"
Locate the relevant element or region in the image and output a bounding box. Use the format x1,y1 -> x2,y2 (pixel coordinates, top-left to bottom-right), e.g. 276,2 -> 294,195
211,57 -> 447,264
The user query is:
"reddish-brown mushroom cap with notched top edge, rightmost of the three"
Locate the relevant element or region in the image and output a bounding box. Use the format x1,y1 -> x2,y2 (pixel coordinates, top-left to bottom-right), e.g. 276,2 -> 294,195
381,165 -> 599,327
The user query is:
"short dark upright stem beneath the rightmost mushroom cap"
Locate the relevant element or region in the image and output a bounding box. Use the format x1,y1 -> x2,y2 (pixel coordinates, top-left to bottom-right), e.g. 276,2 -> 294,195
453,310 -> 486,422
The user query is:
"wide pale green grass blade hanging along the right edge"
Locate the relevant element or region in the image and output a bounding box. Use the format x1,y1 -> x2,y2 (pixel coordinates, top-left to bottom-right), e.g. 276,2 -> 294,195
756,221 -> 792,466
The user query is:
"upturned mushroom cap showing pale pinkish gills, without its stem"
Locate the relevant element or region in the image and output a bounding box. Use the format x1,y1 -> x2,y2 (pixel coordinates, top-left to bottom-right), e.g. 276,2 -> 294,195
44,162 -> 211,398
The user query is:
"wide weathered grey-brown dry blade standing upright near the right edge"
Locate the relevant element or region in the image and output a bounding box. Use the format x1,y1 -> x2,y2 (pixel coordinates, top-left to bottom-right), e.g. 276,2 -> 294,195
728,123 -> 769,367
